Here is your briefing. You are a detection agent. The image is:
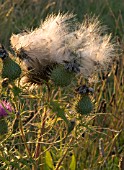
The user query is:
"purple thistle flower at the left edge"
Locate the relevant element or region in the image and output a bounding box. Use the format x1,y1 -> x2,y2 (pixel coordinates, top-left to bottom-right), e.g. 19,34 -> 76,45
0,101 -> 12,118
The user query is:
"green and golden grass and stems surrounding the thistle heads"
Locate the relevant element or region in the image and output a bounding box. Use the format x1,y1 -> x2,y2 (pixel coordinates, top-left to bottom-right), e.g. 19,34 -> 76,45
0,0 -> 124,170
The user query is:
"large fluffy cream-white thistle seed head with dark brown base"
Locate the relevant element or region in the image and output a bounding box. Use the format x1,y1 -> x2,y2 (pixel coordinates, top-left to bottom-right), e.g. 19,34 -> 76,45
11,13 -> 115,81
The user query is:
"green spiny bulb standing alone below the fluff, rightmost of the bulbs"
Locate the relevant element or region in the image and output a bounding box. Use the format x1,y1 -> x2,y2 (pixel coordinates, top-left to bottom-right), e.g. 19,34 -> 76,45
76,95 -> 93,115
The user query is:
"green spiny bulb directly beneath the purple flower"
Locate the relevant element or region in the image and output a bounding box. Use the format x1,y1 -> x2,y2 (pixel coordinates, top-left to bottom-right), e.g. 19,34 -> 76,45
0,118 -> 8,135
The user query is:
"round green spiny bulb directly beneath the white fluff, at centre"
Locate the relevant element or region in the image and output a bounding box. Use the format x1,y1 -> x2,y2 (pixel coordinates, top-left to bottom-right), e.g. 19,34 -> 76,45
51,65 -> 75,87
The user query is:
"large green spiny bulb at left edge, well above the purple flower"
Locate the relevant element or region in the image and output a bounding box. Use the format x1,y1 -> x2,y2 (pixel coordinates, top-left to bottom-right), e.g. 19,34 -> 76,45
2,57 -> 21,81
